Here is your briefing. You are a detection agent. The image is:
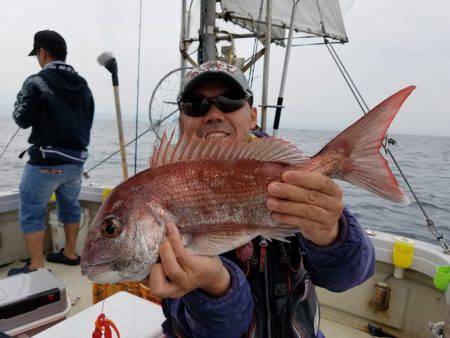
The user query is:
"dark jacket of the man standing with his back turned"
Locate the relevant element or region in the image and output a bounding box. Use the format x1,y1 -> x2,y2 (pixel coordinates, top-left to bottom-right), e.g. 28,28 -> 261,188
13,61 -> 94,164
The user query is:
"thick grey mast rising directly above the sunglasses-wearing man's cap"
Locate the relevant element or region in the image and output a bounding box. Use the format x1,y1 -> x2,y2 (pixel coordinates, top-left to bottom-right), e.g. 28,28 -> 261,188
198,0 -> 217,64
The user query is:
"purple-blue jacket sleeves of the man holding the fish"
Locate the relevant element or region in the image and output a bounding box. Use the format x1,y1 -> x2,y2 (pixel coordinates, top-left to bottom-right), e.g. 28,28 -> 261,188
163,209 -> 375,338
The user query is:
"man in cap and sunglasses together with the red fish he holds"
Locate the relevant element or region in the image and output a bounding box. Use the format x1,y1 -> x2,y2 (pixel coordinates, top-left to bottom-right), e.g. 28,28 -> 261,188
81,61 -> 414,337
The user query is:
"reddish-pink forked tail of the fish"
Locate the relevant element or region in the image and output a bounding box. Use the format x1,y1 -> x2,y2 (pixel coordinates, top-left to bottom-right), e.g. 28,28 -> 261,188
312,86 -> 416,204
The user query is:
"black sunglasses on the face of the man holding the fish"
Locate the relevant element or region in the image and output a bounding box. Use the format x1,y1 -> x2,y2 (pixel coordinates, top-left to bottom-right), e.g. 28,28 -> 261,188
178,93 -> 251,117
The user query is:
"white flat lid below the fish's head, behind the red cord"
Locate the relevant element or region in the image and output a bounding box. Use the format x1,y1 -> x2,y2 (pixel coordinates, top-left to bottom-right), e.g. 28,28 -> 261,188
33,291 -> 164,338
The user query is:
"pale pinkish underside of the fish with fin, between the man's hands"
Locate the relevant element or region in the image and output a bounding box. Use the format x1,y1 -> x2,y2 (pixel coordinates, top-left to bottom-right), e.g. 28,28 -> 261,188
180,223 -> 299,256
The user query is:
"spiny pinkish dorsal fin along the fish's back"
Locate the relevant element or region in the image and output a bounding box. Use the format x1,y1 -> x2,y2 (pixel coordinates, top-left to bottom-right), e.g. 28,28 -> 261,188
150,132 -> 308,167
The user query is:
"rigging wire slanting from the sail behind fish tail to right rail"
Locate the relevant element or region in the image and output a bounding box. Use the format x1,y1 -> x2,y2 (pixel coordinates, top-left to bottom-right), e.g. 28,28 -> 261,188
324,39 -> 450,255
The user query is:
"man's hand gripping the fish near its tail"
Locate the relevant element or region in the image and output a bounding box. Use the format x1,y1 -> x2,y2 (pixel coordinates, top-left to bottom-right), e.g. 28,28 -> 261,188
267,171 -> 344,246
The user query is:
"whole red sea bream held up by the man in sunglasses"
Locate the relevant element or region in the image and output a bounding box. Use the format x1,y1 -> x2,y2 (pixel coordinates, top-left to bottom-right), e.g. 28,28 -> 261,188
81,86 -> 415,283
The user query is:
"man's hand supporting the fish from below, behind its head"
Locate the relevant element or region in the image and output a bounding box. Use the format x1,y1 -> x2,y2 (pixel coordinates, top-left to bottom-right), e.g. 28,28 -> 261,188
149,224 -> 231,298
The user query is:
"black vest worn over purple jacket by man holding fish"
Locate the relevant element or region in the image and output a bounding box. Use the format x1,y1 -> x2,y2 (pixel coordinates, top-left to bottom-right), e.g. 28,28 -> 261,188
162,237 -> 319,338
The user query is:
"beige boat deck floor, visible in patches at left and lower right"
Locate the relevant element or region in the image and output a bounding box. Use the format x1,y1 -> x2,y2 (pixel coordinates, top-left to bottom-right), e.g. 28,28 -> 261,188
0,262 -> 370,338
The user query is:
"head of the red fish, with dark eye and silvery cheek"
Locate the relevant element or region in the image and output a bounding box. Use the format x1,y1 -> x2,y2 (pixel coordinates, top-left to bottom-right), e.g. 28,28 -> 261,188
81,181 -> 164,284
